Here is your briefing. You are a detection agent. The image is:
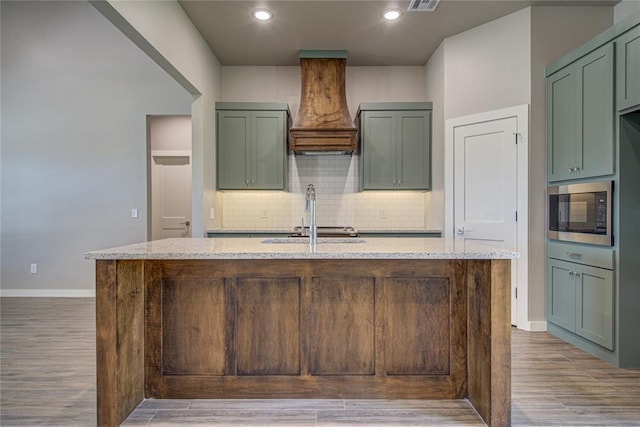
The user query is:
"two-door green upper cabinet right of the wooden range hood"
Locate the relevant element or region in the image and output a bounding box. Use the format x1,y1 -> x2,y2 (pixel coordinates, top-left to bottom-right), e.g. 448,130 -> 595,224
357,102 -> 432,190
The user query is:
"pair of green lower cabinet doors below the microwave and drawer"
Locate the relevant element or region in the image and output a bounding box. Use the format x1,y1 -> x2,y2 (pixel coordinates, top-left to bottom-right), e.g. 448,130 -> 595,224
547,258 -> 614,350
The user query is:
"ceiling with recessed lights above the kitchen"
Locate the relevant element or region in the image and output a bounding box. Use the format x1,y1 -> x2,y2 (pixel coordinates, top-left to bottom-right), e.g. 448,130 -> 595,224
179,0 -> 619,66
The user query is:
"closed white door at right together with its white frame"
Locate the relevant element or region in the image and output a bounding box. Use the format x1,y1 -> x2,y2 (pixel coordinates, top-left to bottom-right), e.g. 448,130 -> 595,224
445,105 -> 529,329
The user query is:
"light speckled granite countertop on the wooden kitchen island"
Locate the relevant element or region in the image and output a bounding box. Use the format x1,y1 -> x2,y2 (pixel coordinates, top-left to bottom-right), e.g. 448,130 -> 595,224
84,237 -> 520,259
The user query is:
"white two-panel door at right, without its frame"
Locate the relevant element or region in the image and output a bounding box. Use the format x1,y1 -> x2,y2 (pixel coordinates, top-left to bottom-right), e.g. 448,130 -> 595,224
453,117 -> 518,324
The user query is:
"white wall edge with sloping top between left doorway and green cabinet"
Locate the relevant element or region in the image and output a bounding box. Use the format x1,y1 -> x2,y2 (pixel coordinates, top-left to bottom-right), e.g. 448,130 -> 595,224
92,0 -> 221,237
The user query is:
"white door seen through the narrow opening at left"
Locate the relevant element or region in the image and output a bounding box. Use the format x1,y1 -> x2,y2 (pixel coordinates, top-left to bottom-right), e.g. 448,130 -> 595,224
151,151 -> 191,240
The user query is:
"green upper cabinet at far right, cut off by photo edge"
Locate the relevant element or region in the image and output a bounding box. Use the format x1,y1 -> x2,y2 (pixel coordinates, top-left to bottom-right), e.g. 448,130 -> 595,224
616,27 -> 640,110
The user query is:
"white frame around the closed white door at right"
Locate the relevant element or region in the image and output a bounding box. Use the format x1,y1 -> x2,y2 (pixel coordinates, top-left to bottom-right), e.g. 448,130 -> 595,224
444,104 -> 534,331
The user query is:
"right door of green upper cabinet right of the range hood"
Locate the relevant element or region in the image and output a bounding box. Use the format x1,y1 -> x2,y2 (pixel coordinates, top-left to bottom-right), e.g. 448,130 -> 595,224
396,111 -> 431,190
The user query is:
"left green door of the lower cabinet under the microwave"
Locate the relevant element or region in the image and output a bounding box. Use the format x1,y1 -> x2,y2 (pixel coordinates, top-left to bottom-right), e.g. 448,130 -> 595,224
547,258 -> 576,332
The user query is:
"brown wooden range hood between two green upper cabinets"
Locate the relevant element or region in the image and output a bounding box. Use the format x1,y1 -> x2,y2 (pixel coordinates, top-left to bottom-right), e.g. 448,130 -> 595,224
289,50 -> 357,154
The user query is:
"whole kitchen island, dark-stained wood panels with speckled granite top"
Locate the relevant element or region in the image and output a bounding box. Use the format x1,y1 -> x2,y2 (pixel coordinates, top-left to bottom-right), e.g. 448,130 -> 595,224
85,238 -> 518,425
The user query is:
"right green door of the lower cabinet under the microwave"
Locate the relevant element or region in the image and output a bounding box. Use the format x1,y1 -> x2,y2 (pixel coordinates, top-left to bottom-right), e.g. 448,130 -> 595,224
575,266 -> 614,350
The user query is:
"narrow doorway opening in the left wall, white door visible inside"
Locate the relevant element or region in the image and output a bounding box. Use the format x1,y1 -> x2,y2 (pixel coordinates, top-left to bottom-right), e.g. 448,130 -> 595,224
147,116 -> 192,240
